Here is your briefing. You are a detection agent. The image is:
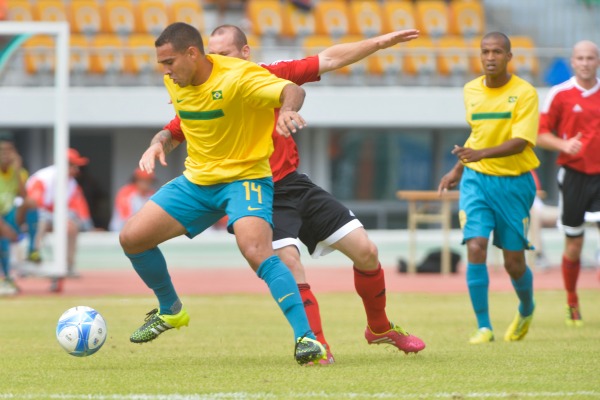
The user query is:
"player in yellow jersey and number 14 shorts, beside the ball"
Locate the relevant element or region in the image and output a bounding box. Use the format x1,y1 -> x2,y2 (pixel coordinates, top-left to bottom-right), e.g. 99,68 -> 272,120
120,23 -> 326,364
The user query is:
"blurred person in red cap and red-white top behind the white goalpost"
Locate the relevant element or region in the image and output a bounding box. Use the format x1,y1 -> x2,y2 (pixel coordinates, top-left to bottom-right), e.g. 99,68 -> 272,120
26,149 -> 92,277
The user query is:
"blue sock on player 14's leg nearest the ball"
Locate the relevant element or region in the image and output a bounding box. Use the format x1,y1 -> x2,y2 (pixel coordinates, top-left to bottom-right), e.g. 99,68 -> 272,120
125,247 -> 181,315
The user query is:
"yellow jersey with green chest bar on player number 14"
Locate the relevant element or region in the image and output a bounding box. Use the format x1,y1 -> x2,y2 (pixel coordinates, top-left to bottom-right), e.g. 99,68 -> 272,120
164,55 -> 291,185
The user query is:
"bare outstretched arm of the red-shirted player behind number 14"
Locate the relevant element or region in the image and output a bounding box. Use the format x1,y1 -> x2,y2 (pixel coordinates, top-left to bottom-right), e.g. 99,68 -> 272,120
319,29 -> 419,75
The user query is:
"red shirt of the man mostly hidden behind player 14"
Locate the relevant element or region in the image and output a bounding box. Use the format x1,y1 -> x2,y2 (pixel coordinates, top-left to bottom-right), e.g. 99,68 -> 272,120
164,56 -> 321,182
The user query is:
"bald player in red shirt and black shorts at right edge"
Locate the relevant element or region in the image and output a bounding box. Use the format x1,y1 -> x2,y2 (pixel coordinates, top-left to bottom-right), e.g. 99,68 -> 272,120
537,40 -> 600,326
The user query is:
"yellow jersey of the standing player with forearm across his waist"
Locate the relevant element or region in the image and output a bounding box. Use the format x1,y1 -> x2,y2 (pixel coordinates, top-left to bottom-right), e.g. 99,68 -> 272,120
464,75 -> 540,176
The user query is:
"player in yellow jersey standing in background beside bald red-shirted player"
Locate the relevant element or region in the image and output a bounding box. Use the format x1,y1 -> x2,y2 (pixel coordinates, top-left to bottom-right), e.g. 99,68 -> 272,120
438,32 -> 539,344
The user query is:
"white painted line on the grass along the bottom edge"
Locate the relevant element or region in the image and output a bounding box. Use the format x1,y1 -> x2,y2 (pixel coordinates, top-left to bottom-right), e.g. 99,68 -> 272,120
0,391 -> 600,400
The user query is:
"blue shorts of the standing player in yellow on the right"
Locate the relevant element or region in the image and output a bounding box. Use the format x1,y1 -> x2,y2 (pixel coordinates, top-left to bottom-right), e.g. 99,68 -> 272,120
459,167 -> 535,251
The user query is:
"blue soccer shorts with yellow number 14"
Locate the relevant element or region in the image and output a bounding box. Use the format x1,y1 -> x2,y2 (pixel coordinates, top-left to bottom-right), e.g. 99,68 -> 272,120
150,175 -> 273,238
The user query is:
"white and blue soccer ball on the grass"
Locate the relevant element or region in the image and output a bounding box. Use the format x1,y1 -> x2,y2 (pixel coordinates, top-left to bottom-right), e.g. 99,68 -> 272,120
56,306 -> 106,357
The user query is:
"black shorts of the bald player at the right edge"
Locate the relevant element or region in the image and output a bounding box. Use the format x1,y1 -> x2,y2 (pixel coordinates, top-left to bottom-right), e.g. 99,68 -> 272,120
557,167 -> 600,237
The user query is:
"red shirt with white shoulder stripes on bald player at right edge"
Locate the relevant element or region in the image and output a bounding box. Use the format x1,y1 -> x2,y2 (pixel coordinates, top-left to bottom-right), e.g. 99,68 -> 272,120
539,77 -> 600,175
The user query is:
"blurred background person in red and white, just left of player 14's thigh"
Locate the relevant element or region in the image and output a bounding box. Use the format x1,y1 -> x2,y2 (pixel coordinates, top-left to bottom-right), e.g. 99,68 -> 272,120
110,168 -> 156,231
